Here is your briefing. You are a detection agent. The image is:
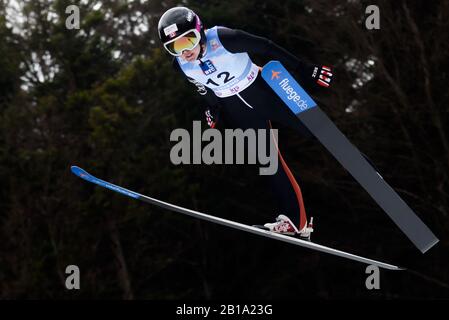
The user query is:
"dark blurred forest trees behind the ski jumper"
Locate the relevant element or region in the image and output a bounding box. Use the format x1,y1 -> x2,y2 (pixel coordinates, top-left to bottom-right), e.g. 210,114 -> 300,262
0,0 -> 449,300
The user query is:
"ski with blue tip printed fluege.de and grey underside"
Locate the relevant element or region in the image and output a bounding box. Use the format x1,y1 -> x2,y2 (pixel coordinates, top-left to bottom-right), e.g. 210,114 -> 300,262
262,61 -> 439,253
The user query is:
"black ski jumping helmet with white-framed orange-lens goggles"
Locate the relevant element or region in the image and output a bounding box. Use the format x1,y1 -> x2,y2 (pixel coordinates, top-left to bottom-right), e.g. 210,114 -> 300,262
157,7 -> 206,58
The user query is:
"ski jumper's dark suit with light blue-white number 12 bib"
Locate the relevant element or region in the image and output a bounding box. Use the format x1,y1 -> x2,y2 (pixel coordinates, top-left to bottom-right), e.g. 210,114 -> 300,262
173,27 -> 313,230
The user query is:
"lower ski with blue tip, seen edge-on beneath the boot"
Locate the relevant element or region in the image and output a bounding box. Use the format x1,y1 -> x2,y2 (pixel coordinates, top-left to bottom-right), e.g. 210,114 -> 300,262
71,166 -> 404,270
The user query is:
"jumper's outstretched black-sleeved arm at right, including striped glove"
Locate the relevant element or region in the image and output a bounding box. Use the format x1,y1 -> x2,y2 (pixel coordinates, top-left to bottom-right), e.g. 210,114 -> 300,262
218,27 -> 332,87
